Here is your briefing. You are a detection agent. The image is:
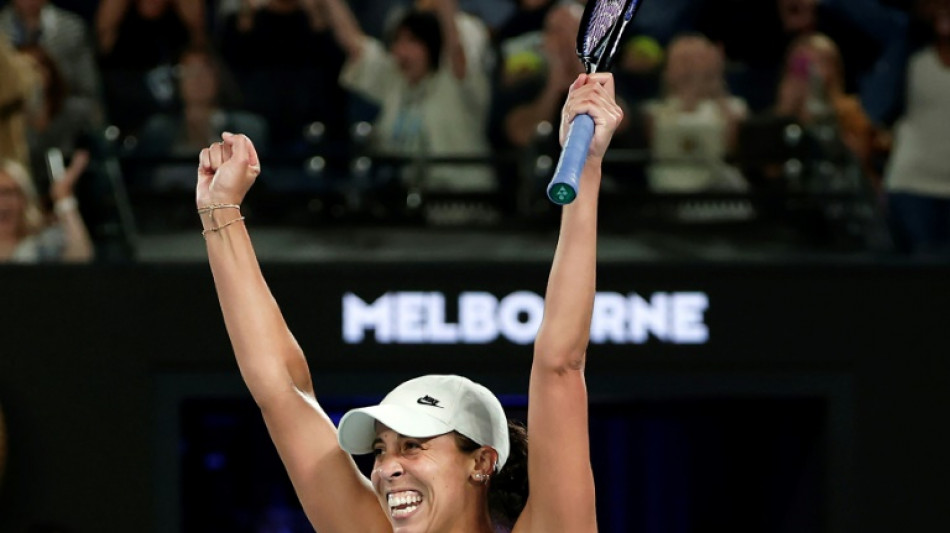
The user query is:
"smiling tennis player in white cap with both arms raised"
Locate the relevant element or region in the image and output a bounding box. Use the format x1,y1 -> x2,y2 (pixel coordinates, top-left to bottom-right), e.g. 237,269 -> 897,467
197,74 -> 622,533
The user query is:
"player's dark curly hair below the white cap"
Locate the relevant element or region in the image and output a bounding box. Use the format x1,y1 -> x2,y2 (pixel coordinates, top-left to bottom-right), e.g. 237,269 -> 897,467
455,420 -> 528,529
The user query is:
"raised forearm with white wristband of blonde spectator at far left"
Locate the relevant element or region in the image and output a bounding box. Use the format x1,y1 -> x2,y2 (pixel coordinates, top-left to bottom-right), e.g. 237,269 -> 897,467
50,150 -> 95,262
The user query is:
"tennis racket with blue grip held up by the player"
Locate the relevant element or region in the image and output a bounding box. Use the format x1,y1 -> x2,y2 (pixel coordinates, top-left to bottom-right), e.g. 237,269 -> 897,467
547,0 -> 642,205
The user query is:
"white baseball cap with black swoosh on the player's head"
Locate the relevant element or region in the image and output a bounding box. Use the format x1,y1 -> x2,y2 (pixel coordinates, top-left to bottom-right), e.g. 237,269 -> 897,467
338,375 -> 510,471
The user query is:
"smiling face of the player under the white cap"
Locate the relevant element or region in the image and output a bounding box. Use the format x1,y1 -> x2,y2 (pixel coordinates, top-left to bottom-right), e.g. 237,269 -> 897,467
371,423 -> 475,533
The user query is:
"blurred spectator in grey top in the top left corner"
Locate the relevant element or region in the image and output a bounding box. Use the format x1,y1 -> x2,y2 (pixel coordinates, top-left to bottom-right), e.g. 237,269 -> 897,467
0,0 -> 100,110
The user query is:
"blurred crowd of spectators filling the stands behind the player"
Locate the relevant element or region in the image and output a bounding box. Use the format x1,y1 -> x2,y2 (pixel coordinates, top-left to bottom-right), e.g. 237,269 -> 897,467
0,0 -> 950,262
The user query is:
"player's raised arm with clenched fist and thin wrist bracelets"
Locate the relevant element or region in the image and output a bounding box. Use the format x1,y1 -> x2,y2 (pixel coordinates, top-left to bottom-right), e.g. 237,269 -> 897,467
197,133 -> 392,533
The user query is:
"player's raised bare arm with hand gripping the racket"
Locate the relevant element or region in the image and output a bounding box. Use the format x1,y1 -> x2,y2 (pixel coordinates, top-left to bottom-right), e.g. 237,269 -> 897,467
519,74 -> 623,533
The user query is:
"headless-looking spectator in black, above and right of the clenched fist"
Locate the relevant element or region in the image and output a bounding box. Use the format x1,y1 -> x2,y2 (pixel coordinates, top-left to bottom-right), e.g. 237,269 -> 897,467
218,0 -> 346,154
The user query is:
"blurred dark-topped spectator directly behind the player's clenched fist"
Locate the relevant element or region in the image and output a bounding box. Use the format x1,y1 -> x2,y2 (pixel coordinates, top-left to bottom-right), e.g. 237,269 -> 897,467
138,48 -> 269,188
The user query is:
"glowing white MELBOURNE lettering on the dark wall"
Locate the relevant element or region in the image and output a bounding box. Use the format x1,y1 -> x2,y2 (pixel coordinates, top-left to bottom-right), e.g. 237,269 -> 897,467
343,291 -> 709,344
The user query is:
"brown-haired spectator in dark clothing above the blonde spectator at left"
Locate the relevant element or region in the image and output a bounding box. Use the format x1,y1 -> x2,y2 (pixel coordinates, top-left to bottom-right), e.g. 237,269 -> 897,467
21,46 -> 96,197
